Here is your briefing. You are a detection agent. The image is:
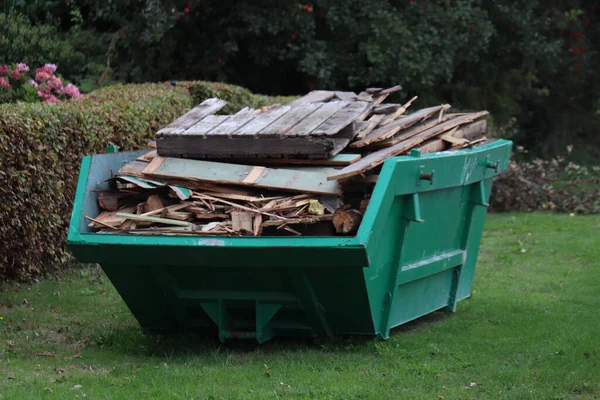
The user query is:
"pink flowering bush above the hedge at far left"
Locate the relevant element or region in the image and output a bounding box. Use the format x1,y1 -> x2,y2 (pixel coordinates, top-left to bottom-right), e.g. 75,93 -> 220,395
0,62 -> 82,103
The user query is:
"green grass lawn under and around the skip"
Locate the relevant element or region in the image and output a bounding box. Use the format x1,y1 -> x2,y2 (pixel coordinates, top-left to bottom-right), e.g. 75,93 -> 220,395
0,214 -> 600,399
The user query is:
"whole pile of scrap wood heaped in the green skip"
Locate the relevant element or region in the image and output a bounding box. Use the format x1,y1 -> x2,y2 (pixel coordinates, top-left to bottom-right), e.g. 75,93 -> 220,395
86,86 -> 487,236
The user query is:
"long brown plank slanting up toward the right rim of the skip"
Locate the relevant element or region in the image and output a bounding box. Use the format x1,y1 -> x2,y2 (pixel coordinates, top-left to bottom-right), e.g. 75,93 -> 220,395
327,111 -> 488,180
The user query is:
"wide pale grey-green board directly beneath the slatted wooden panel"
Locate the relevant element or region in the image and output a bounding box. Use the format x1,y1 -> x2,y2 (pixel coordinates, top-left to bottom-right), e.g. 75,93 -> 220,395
144,157 -> 341,194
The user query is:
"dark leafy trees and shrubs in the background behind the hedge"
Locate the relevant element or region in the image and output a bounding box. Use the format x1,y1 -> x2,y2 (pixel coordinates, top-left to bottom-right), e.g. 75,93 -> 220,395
0,0 -> 600,162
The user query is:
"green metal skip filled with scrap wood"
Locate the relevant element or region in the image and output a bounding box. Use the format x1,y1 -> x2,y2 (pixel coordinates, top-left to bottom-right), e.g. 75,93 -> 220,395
68,140 -> 512,342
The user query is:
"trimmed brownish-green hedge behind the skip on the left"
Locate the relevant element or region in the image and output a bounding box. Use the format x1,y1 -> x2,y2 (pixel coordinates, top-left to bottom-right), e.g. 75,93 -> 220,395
0,82 -> 286,280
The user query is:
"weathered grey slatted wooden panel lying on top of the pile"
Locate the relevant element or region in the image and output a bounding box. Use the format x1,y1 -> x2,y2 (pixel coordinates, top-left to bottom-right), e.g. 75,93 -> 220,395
156,87 -> 400,159
